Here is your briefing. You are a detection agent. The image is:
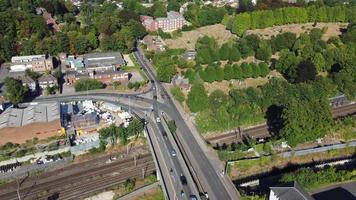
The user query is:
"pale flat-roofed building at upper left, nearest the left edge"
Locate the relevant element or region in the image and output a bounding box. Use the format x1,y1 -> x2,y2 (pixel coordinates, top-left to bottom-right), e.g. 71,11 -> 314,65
10,54 -> 53,72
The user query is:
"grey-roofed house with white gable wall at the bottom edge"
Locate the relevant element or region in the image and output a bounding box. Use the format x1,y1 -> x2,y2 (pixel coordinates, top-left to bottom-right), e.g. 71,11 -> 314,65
269,181 -> 315,200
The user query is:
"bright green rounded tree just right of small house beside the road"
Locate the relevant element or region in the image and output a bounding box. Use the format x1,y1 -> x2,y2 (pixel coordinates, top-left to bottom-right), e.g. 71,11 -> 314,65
187,83 -> 209,112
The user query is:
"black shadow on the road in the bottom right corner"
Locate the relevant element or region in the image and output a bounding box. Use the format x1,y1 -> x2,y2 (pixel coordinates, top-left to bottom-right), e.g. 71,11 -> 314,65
313,187 -> 356,200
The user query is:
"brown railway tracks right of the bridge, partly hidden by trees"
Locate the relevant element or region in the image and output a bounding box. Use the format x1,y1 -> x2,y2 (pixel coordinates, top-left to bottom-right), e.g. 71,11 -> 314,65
206,103 -> 356,145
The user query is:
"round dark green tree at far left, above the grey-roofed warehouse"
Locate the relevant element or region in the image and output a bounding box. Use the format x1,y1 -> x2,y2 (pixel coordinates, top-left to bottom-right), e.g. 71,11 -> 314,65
4,77 -> 28,106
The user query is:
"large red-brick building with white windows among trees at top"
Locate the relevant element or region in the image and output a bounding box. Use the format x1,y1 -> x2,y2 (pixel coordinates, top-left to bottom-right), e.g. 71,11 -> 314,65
140,11 -> 187,32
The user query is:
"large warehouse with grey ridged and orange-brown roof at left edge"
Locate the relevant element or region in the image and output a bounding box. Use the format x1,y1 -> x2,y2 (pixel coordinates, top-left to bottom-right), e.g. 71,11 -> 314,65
0,102 -> 61,145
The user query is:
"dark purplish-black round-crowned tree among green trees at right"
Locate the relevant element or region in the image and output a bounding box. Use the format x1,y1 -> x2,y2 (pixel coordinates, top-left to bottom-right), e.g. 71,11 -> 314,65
295,60 -> 317,83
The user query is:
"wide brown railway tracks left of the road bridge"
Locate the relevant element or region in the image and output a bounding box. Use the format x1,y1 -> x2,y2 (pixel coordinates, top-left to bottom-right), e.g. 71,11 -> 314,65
0,154 -> 155,199
